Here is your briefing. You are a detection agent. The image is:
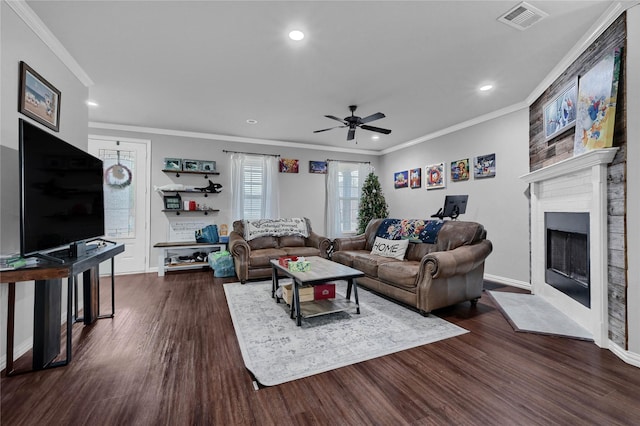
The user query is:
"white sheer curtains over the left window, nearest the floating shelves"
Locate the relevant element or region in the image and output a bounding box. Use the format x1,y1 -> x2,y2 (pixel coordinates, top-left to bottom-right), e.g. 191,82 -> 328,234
231,153 -> 280,221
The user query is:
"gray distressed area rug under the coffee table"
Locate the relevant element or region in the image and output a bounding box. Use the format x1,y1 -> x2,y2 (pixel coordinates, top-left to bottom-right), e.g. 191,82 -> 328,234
224,281 -> 468,386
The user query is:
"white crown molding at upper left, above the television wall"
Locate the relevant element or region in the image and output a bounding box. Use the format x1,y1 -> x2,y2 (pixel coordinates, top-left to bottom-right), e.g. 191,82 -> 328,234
4,0 -> 93,87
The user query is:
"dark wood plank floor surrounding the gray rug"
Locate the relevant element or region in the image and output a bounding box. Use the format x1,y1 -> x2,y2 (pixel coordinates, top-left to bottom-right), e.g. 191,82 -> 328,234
0,272 -> 640,425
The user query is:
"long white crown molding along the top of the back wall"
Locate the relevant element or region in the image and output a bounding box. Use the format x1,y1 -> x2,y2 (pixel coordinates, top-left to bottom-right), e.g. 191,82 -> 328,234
89,121 -> 382,156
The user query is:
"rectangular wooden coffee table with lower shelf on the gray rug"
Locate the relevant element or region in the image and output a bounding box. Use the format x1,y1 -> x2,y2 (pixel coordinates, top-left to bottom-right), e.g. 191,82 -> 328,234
271,256 -> 364,326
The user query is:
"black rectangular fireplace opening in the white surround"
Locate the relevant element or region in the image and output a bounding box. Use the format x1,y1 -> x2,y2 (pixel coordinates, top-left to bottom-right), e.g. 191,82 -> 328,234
544,212 -> 591,308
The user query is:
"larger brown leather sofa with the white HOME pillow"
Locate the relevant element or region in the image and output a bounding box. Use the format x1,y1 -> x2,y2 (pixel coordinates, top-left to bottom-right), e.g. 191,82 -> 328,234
331,219 -> 492,315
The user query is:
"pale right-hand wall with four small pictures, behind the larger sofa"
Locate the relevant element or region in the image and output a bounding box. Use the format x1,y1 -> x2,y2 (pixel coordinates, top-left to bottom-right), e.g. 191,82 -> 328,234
380,108 -> 530,287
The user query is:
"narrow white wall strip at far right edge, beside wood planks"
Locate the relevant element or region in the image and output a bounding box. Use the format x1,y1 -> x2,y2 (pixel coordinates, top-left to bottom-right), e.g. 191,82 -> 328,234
626,6 -> 640,365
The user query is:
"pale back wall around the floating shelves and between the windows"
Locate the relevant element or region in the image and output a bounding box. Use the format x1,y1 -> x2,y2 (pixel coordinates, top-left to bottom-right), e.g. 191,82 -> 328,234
91,128 -> 379,269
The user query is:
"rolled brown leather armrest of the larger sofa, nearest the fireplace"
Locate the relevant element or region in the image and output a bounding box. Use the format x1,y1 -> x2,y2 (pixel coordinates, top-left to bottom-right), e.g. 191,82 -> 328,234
421,240 -> 493,279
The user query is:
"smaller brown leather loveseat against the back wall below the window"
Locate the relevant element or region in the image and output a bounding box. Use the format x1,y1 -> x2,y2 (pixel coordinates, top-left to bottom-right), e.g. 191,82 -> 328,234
229,218 -> 331,284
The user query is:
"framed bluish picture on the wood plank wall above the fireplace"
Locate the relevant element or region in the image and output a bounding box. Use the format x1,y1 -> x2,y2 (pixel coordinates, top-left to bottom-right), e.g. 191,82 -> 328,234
542,78 -> 578,140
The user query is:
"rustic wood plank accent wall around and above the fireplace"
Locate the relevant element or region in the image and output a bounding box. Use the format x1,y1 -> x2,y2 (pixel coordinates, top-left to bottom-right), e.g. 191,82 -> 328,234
529,13 -> 627,349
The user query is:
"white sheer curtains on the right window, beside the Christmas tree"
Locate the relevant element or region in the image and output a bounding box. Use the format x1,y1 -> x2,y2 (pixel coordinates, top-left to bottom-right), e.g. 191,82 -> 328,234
325,160 -> 373,239
